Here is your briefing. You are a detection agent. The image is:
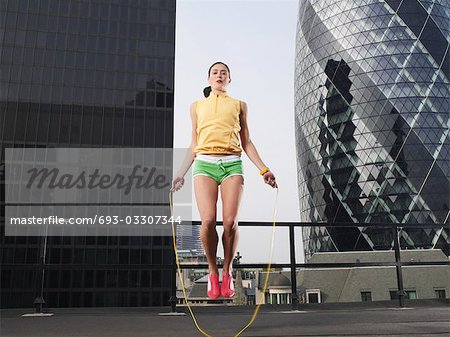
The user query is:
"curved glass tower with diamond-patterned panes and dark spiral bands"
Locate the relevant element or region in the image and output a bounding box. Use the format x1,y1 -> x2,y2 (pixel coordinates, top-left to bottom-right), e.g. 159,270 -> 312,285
295,0 -> 450,258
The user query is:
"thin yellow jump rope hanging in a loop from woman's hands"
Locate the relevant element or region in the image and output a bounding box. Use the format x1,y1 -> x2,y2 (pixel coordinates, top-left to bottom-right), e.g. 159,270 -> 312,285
169,187 -> 279,337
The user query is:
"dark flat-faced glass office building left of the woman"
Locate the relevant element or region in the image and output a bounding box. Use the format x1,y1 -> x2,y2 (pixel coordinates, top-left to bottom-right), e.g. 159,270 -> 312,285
0,0 -> 175,308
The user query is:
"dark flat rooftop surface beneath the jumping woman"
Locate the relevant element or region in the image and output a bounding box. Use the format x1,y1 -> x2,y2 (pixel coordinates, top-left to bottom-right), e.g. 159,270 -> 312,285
0,301 -> 450,337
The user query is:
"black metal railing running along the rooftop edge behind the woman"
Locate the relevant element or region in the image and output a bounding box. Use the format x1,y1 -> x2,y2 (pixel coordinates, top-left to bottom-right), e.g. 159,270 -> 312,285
2,221 -> 450,312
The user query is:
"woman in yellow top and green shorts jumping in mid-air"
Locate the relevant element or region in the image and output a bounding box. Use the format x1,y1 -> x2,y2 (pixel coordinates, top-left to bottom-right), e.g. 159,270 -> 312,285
172,62 -> 278,299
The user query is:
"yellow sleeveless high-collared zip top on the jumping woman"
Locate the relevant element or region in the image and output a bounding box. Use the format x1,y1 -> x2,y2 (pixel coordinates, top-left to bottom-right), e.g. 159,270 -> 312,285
194,92 -> 242,155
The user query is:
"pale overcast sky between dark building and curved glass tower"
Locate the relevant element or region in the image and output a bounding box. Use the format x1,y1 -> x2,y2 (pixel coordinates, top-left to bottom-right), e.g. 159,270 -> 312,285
174,0 -> 303,263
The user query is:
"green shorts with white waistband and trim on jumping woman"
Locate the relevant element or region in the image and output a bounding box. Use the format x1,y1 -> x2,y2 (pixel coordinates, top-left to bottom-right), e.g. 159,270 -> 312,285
193,155 -> 244,185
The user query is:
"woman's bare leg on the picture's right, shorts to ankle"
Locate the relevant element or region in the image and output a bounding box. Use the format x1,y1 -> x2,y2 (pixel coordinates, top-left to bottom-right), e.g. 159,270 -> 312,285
220,175 -> 244,275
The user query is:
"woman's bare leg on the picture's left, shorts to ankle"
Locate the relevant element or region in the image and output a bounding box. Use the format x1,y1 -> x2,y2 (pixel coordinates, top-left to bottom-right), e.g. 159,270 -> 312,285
194,176 -> 219,274
